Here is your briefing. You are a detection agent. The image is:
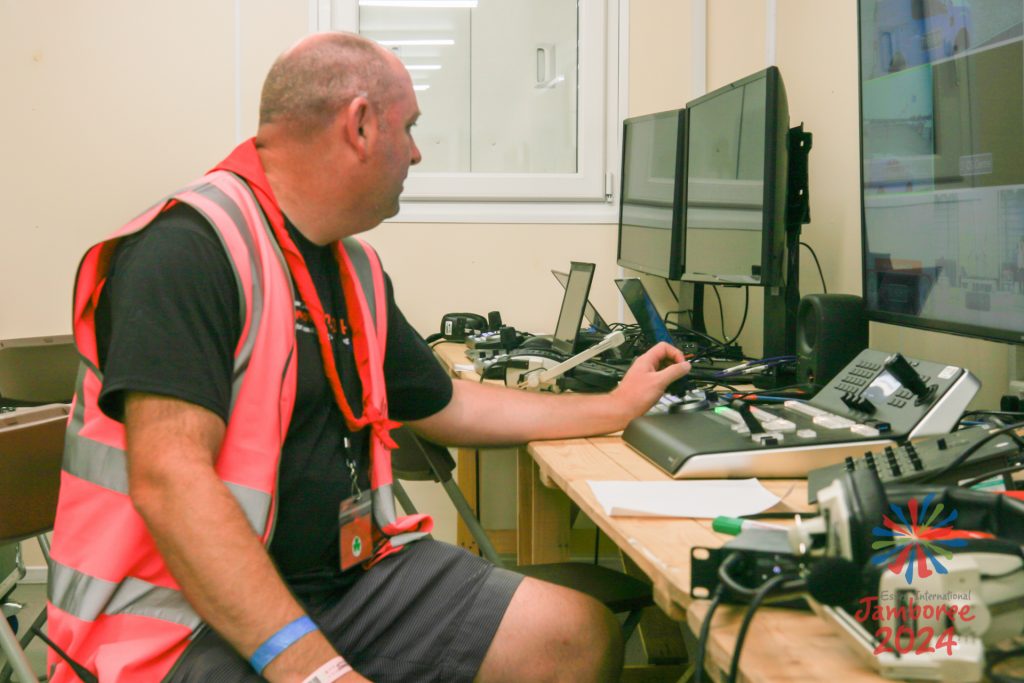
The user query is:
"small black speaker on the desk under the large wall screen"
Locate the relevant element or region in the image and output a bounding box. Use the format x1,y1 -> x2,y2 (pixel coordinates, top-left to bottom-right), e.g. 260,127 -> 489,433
797,294 -> 867,386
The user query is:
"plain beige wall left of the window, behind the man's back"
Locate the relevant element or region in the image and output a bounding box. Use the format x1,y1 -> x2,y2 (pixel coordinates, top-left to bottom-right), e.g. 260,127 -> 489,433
0,0 -> 308,338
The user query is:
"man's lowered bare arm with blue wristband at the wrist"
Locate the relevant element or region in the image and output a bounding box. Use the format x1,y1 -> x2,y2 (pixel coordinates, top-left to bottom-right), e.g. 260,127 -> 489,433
125,393 -> 365,683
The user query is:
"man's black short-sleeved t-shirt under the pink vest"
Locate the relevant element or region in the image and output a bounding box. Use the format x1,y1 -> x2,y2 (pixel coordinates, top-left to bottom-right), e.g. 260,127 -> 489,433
96,205 -> 452,594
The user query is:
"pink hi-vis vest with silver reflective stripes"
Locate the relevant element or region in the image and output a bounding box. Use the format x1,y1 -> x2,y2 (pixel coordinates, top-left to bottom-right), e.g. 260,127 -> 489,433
48,170 -> 432,683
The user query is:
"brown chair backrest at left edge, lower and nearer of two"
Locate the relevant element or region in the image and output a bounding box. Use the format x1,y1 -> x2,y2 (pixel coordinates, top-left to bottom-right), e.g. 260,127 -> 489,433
0,404 -> 71,543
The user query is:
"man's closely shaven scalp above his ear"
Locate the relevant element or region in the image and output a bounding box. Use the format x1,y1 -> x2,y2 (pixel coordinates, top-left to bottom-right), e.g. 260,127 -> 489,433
259,33 -> 400,133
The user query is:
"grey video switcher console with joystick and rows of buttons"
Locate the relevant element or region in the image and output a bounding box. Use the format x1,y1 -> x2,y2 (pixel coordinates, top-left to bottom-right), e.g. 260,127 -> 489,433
623,349 -> 980,478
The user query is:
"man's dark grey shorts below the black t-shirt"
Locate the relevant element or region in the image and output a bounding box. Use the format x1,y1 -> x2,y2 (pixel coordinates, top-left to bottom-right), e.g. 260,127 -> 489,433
167,540 -> 522,683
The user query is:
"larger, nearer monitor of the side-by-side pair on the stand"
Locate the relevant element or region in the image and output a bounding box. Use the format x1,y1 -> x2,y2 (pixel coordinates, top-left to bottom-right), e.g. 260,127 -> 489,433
682,67 -> 790,287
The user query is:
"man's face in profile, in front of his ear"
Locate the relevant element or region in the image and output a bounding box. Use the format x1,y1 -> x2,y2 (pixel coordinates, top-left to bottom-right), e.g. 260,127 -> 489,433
375,68 -> 422,220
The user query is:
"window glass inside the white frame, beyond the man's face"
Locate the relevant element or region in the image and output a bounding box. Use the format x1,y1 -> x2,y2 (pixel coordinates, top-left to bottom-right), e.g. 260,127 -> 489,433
358,0 -> 579,174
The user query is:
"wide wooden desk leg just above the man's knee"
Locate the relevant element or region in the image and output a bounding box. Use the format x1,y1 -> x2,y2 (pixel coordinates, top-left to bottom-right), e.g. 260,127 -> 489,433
516,449 -> 569,564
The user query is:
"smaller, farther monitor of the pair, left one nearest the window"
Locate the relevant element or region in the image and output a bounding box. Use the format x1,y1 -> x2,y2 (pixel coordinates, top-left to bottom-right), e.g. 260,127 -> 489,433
617,110 -> 686,280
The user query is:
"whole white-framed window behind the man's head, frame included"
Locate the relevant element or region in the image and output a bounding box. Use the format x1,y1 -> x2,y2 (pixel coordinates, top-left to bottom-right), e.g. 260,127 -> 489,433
327,0 -> 621,208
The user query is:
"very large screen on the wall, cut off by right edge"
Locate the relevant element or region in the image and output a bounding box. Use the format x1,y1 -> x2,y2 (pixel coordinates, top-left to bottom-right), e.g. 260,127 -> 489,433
858,0 -> 1024,344
